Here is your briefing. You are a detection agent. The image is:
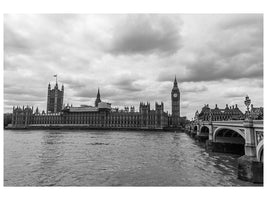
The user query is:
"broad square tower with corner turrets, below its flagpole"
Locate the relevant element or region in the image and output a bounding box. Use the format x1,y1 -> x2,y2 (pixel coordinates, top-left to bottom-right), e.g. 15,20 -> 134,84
46,82 -> 64,113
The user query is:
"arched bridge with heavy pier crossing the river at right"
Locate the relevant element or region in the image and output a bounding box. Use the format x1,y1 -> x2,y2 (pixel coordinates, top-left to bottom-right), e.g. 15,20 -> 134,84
185,119 -> 264,183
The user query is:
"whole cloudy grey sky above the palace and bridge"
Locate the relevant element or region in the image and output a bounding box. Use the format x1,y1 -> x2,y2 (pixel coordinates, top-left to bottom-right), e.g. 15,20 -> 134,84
4,14 -> 263,119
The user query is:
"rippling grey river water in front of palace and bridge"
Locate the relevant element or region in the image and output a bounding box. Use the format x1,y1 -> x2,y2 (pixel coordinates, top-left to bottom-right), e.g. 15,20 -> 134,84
4,130 -> 260,186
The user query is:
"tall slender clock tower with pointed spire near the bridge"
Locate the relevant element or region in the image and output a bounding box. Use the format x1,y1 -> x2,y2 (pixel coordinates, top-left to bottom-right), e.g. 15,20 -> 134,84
171,76 -> 180,126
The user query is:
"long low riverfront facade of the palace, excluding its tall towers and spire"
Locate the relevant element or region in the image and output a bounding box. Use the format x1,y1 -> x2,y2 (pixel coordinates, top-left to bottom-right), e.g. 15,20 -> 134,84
12,103 -> 168,129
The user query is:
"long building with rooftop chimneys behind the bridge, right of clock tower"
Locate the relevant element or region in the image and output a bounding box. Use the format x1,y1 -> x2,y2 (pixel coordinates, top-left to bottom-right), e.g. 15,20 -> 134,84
195,104 -> 245,121
